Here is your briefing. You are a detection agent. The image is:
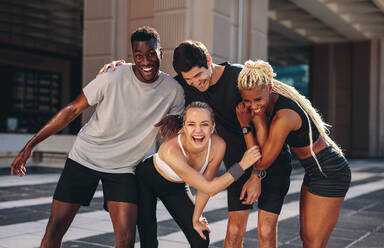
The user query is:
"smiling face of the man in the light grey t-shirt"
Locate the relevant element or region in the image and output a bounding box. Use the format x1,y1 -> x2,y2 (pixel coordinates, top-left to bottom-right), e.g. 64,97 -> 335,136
132,39 -> 163,83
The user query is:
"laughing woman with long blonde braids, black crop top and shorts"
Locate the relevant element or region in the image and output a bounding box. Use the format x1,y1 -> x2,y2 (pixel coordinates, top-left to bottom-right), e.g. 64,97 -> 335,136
236,60 -> 351,247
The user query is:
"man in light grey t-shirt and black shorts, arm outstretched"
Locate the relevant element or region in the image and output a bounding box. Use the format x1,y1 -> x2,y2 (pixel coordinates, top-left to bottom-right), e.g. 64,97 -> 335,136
11,26 -> 184,247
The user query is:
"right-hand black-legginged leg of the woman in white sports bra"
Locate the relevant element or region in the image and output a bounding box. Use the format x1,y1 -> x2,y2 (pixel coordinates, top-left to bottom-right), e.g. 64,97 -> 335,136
160,185 -> 209,248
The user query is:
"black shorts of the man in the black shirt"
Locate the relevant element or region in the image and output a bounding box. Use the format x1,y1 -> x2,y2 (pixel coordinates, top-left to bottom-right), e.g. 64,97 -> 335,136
227,150 -> 292,214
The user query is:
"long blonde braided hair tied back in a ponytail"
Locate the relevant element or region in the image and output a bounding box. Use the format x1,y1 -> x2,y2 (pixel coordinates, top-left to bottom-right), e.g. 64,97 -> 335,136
237,60 -> 343,174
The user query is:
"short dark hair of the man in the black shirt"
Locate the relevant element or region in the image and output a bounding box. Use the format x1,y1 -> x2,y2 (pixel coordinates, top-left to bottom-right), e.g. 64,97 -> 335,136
173,40 -> 208,74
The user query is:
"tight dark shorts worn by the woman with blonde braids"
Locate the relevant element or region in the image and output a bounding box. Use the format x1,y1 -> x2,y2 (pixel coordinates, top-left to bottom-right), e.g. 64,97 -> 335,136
300,146 -> 351,197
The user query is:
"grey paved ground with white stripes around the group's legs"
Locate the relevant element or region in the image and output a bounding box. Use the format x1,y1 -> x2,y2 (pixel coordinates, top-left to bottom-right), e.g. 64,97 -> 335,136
0,160 -> 384,248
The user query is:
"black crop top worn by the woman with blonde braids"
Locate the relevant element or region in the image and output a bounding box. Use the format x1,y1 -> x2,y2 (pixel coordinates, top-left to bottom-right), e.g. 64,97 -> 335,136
272,94 -> 320,147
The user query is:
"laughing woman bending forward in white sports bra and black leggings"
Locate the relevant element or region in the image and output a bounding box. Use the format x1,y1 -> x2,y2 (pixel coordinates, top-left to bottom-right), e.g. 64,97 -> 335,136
136,102 -> 260,248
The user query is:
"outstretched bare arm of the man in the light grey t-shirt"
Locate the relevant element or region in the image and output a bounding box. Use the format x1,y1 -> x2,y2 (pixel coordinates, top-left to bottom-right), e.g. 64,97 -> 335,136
11,93 -> 89,176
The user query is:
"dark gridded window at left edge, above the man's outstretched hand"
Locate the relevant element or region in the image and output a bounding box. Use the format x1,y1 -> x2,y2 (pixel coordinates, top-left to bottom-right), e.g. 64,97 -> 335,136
0,66 -> 62,133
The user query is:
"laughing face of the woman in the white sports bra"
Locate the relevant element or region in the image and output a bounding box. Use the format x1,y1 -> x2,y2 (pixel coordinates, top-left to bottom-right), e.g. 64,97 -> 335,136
183,107 -> 215,149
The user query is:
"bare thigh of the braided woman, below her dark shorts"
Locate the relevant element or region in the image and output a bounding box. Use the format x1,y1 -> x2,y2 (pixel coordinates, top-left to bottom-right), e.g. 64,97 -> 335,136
300,185 -> 344,248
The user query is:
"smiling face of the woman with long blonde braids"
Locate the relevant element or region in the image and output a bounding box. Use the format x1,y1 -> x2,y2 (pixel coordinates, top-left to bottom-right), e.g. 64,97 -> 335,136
240,86 -> 272,115
